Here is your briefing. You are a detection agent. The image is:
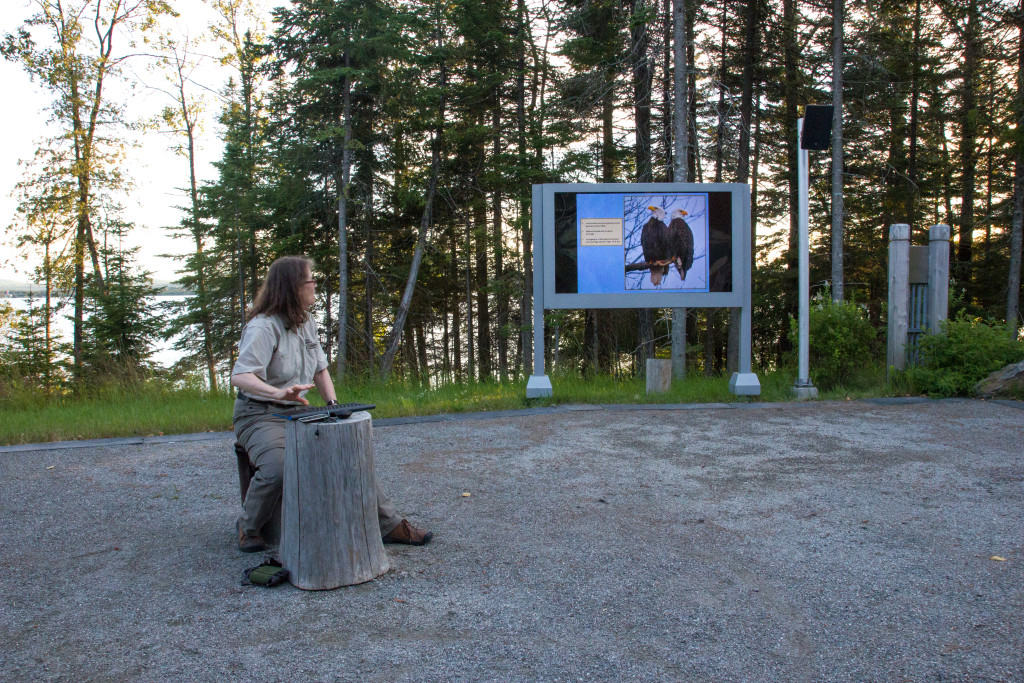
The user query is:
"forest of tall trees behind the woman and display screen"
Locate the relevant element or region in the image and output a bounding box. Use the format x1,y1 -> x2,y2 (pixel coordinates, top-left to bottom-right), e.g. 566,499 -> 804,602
0,0 -> 1024,395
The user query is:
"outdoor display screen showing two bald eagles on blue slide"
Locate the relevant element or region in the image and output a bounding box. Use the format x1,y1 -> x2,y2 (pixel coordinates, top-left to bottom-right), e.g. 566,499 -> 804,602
553,191 -> 733,294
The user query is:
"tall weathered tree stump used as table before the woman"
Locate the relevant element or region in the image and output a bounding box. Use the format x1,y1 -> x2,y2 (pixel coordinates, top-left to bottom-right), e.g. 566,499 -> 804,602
281,412 -> 388,591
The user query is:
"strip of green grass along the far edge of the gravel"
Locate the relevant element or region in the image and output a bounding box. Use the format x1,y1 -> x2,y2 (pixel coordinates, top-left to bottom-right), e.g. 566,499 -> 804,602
0,367 -> 905,445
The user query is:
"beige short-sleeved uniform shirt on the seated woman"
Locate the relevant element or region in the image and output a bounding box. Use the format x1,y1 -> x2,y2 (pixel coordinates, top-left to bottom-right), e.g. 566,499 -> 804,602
231,315 -> 327,405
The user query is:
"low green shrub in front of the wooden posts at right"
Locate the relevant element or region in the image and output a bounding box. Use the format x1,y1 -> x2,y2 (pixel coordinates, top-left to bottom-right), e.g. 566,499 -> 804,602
905,315 -> 1024,396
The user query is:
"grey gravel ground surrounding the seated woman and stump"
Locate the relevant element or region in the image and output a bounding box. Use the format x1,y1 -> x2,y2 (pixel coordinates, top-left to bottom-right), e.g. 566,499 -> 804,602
0,400 -> 1024,682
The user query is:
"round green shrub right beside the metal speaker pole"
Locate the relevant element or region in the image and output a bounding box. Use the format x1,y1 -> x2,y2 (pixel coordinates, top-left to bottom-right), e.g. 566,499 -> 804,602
790,291 -> 878,389
